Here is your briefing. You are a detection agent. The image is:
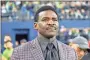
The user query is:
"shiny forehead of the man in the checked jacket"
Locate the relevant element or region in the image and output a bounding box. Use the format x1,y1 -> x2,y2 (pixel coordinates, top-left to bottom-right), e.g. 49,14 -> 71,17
39,10 -> 57,18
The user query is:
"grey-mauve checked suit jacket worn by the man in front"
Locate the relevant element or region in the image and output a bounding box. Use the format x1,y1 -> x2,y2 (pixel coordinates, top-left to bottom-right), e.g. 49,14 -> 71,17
11,38 -> 77,60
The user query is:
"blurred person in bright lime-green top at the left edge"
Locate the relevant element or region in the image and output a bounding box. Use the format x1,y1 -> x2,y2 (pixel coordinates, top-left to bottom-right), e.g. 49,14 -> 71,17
2,35 -> 13,60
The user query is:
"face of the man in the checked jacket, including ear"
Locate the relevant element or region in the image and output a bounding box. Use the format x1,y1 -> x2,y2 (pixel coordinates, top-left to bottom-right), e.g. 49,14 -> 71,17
34,10 -> 59,38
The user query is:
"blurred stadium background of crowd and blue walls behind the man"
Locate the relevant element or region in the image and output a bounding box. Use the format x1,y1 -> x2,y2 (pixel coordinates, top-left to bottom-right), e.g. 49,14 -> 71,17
0,0 -> 90,52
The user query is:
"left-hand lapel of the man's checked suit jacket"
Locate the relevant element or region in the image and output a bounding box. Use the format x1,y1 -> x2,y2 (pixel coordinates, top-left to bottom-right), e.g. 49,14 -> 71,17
31,39 -> 44,60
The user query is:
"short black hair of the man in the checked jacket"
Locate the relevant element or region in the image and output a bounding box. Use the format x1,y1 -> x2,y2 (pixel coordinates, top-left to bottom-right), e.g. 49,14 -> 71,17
34,5 -> 58,22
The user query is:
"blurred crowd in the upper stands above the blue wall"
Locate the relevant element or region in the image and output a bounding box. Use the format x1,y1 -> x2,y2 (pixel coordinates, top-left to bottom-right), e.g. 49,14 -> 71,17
1,1 -> 90,20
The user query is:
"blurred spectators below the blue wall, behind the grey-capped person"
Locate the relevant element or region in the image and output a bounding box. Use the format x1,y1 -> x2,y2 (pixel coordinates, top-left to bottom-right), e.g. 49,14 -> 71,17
57,26 -> 90,44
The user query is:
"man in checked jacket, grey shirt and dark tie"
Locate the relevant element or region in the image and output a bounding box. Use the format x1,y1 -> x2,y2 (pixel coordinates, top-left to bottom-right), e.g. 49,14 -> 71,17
11,6 -> 77,60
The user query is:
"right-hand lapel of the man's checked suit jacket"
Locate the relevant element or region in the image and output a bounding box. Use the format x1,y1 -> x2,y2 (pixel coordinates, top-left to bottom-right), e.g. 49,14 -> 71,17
58,41 -> 67,60
